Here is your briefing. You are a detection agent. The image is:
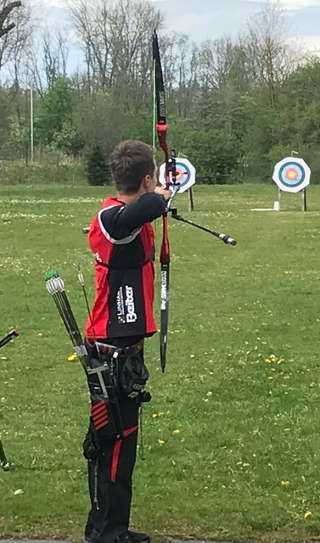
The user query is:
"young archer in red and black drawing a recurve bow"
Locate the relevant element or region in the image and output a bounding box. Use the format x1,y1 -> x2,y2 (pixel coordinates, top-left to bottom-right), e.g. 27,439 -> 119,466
84,140 -> 170,543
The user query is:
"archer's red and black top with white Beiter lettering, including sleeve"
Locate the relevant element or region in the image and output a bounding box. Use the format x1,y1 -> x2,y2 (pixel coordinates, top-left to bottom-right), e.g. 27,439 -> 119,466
85,193 -> 165,339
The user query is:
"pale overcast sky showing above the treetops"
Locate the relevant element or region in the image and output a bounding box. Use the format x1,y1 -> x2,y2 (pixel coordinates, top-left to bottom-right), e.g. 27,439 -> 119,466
26,0 -> 320,59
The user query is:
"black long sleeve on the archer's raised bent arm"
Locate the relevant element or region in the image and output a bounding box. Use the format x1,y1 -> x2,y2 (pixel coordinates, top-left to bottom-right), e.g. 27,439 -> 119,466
101,192 -> 166,239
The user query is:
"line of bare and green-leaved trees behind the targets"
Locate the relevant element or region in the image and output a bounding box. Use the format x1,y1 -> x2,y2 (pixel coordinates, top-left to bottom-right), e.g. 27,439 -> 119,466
0,0 -> 320,184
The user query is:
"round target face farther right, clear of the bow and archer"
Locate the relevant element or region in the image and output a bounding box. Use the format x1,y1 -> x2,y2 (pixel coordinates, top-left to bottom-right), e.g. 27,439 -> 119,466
272,157 -> 311,192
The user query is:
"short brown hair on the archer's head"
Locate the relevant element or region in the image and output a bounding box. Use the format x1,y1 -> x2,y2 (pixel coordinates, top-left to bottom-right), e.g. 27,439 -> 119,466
111,140 -> 155,194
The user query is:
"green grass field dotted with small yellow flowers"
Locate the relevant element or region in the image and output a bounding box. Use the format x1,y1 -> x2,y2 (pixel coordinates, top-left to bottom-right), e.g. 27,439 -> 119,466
0,185 -> 320,542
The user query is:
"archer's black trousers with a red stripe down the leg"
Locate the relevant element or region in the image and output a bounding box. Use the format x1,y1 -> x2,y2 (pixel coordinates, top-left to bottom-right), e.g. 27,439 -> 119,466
83,344 -> 147,543
